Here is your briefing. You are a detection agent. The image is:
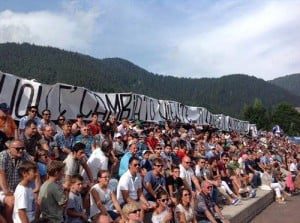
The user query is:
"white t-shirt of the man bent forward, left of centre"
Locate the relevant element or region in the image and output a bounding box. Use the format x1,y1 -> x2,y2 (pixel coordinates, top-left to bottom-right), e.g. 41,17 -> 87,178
81,148 -> 108,180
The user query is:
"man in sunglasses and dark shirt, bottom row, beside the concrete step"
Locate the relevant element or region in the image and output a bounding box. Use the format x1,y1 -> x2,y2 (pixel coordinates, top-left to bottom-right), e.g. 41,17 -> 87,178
195,181 -> 229,223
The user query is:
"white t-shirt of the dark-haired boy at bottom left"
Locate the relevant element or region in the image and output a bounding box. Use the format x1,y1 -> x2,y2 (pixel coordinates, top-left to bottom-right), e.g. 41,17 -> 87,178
13,184 -> 35,223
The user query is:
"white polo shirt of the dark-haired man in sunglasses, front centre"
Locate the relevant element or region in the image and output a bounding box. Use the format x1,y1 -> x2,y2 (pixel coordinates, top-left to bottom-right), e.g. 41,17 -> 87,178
117,170 -> 142,204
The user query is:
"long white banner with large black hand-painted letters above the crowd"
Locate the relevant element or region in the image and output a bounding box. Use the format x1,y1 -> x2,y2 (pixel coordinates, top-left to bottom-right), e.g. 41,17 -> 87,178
0,72 -> 254,133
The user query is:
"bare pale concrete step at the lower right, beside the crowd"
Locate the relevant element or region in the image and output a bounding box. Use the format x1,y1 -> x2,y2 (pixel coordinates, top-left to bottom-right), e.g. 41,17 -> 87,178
222,189 -> 274,223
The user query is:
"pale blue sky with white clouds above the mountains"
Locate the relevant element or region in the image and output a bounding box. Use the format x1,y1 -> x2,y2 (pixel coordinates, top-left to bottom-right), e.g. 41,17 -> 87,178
0,0 -> 300,80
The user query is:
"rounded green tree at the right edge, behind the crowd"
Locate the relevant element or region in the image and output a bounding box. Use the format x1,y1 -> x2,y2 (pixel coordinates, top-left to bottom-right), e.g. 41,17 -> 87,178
272,103 -> 300,136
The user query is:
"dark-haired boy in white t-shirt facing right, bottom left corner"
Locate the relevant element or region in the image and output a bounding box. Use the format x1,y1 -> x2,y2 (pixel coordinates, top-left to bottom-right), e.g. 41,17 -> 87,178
13,161 -> 37,223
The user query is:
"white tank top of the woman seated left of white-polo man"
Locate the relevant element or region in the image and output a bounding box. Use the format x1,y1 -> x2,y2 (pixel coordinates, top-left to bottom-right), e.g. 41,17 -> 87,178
90,184 -> 113,217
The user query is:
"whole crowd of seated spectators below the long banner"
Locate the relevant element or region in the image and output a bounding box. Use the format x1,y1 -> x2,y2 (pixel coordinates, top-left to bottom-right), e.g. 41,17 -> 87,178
0,103 -> 300,223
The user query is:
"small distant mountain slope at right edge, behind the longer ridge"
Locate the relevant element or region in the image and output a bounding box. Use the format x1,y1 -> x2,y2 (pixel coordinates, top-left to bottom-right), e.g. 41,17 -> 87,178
270,73 -> 300,96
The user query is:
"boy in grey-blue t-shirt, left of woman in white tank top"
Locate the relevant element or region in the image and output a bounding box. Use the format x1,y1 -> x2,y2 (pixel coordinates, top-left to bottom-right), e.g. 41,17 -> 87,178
66,175 -> 88,223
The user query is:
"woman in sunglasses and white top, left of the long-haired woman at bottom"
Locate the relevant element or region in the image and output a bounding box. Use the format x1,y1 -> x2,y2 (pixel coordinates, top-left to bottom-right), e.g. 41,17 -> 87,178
151,191 -> 173,223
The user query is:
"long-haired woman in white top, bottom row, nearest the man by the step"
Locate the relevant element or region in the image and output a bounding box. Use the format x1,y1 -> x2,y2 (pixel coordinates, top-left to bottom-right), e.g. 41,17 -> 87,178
175,188 -> 197,223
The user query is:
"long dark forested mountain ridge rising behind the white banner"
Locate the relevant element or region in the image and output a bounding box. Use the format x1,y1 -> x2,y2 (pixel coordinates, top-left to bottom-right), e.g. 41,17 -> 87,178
0,43 -> 300,117
